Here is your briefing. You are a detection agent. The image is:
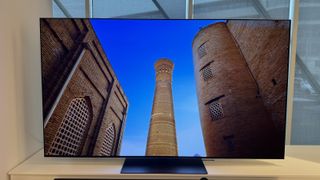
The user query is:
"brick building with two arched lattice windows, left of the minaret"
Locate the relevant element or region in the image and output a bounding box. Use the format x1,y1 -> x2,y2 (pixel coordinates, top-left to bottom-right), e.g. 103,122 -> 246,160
40,19 -> 128,156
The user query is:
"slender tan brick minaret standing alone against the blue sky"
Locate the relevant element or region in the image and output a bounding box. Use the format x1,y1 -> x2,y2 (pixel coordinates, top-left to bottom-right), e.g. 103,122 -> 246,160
146,59 -> 178,156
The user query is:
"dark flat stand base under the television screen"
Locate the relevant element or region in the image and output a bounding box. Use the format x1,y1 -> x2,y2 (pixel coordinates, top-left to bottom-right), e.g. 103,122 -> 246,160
121,157 -> 208,174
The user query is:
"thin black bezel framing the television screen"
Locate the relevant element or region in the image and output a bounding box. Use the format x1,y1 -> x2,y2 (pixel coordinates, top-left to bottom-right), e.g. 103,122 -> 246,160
39,17 -> 292,160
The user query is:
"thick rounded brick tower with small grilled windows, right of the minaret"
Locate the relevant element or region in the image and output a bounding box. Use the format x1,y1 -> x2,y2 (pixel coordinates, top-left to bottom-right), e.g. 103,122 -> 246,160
193,23 -> 283,158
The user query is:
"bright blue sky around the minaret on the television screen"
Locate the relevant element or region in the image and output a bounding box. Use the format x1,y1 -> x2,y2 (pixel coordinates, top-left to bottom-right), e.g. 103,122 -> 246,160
90,19 -> 225,156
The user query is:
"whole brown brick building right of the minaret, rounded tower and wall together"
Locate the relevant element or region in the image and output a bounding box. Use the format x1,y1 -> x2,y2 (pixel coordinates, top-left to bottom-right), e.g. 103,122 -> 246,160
193,20 -> 290,158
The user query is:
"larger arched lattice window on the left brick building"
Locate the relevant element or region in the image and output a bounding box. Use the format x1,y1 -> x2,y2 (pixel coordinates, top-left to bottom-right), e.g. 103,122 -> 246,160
48,98 -> 91,156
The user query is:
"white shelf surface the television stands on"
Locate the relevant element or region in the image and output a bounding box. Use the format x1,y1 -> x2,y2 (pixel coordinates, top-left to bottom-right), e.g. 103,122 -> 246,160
9,146 -> 320,180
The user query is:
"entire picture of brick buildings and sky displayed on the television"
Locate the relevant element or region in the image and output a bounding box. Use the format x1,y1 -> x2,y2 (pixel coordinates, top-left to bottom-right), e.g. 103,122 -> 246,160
40,18 -> 290,158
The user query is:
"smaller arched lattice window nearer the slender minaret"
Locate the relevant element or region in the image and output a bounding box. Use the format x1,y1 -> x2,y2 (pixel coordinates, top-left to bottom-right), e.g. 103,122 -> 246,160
100,124 -> 115,156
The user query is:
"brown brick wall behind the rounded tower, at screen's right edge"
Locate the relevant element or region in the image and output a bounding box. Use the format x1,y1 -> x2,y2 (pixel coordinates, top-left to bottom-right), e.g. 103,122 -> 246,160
227,20 -> 290,139
